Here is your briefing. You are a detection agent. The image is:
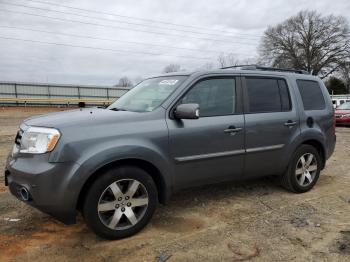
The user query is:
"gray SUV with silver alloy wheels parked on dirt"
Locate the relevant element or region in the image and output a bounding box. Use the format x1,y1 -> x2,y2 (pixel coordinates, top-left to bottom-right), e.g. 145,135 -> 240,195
5,66 -> 336,239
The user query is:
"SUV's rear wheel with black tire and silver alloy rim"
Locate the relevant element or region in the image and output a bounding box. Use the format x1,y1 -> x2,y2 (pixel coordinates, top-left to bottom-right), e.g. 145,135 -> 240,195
281,144 -> 322,193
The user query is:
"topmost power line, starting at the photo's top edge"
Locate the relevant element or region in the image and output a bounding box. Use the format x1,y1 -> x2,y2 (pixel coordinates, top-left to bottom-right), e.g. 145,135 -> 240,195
21,0 -> 262,37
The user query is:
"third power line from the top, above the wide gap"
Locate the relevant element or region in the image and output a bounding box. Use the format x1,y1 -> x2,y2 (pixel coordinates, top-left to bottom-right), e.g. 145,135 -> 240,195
0,8 -> 256,46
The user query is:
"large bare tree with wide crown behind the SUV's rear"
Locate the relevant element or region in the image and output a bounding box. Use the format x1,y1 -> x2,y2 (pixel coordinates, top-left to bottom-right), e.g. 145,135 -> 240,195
260,11 -> 350,78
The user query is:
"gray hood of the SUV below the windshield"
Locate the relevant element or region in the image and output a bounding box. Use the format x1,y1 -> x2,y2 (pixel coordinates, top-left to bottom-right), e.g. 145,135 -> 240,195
24,108 -> 142,128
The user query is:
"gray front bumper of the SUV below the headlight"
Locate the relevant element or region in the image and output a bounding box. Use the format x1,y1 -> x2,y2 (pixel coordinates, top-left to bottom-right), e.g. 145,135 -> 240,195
5,154 -> 79,224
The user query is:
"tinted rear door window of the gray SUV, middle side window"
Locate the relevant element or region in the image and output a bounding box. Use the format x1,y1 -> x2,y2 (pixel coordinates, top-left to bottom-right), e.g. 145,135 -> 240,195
246,77 -> 291,113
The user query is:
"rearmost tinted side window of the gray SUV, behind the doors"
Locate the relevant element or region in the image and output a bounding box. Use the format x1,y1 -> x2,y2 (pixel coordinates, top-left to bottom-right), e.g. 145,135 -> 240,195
297,80 -> 325,110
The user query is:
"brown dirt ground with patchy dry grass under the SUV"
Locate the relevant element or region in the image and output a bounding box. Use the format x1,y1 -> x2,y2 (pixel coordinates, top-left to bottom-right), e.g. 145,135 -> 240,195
0,108 -> 350,262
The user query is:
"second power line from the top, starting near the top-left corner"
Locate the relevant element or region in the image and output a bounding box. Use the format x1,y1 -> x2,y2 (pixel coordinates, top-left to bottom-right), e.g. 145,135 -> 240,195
1,2 -> 259,41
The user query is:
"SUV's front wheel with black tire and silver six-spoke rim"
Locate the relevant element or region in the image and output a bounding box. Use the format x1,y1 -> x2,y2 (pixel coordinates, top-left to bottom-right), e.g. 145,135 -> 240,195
82,166 -> 158,239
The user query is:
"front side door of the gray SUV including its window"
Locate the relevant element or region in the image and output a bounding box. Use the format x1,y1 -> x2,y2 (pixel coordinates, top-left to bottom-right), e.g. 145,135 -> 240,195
167,76 -> 245,188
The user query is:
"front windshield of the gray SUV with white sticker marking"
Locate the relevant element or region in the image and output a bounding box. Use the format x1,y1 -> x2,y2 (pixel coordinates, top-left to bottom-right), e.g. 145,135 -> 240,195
108,76 -> 186,112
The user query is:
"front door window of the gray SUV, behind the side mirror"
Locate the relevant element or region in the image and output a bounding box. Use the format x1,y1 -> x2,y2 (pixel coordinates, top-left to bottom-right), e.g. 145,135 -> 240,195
182,78 -> 236,117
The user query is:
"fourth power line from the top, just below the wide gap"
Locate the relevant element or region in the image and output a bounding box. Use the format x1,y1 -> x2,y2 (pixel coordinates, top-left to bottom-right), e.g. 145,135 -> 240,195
0,25 -> 238,54
